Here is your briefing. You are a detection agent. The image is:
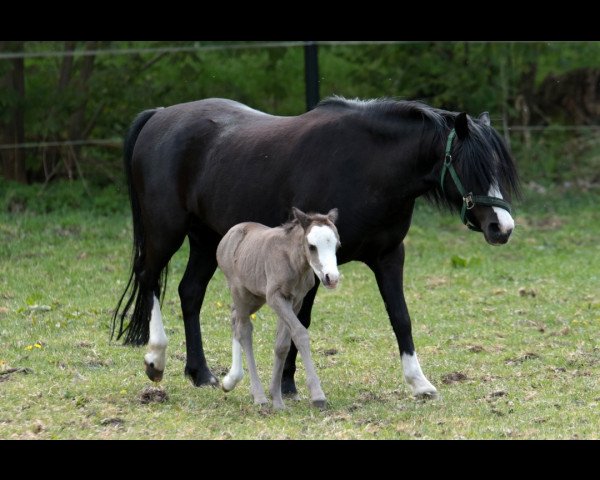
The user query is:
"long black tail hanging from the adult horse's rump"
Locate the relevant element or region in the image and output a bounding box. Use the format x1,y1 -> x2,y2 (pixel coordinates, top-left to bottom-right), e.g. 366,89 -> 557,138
110,109 -> 167,345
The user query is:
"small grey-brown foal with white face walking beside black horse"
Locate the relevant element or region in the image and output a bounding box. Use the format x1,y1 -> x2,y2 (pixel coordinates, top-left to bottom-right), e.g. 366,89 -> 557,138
217,207 -> 340,409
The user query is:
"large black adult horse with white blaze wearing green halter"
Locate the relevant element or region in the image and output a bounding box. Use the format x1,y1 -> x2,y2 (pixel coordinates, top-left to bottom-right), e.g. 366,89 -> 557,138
113,97 -> 518,396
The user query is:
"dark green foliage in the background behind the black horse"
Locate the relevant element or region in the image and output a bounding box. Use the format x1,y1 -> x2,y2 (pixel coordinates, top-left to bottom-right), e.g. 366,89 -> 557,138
0,41 -> 600,183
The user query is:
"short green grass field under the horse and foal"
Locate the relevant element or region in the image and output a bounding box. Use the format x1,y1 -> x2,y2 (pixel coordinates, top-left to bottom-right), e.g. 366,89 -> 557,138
0,183 -> 600,439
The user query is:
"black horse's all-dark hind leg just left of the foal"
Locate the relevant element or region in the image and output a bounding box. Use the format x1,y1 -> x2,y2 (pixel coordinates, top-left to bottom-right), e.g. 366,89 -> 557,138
179,228 -> 219,387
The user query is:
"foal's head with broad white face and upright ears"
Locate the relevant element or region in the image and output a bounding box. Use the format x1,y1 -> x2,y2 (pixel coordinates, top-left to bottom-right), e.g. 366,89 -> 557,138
292,207 -> 340,288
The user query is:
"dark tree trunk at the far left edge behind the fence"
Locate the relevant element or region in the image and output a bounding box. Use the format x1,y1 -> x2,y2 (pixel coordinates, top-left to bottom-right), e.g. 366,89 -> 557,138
0,42 -> 27,183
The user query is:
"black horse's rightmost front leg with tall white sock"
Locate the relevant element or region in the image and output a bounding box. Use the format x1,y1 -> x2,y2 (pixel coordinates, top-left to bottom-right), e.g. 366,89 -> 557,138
366,244 -> 437,398
